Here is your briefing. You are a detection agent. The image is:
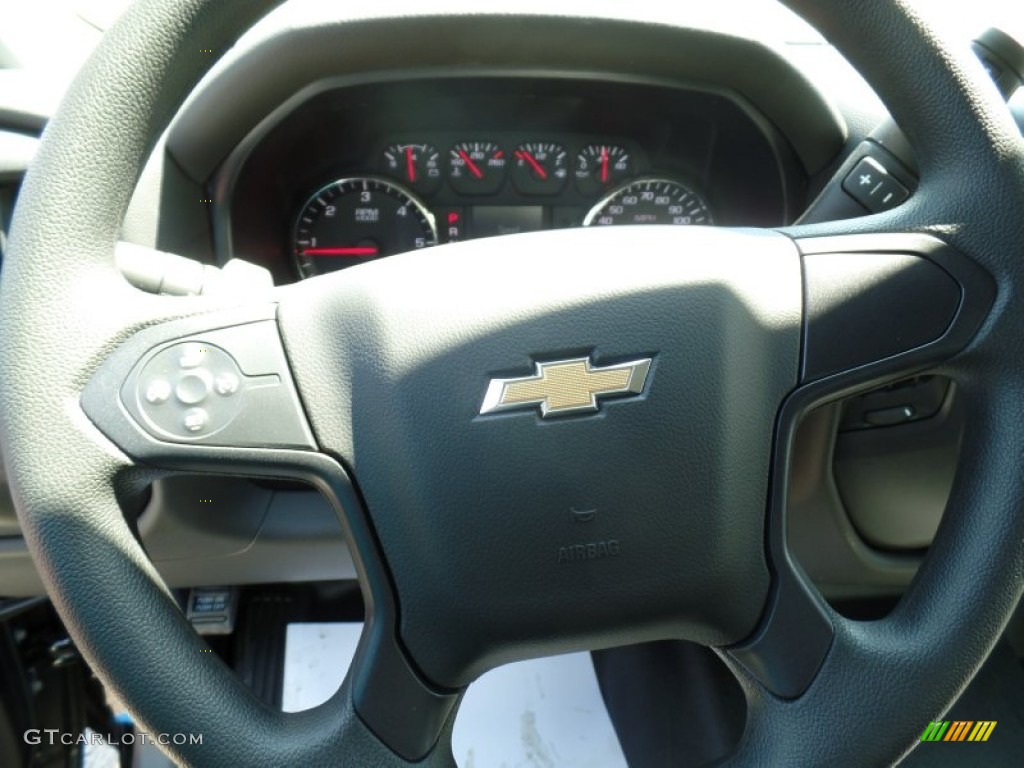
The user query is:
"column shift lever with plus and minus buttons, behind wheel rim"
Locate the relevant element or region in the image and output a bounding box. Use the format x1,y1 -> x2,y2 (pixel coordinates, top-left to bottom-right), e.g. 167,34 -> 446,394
798,27 -> 1024,224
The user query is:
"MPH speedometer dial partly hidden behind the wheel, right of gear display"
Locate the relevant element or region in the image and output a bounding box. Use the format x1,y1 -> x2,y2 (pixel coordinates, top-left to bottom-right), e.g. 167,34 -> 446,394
583,178 -> 715,226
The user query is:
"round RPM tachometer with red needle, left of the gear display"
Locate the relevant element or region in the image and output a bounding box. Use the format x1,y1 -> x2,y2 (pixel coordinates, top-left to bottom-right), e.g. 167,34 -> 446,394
293,177 -> 437,278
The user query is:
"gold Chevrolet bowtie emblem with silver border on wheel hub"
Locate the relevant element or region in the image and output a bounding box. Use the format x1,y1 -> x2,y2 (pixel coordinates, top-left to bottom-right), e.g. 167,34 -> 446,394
480,357 -> 650,417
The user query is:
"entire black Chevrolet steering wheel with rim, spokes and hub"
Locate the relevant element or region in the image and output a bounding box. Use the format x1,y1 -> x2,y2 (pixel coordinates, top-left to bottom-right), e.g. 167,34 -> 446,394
0,0 -> 1024,766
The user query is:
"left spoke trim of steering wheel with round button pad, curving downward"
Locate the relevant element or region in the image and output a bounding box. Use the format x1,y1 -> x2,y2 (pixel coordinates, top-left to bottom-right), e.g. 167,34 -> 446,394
82,291 -> 461,764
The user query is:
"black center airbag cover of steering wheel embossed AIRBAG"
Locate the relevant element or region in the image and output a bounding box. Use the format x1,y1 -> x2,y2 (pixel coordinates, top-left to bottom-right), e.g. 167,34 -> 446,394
280,227 -> 802,688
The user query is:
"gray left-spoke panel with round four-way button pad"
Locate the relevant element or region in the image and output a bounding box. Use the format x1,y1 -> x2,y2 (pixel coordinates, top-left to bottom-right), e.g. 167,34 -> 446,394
107,321 -> 314,447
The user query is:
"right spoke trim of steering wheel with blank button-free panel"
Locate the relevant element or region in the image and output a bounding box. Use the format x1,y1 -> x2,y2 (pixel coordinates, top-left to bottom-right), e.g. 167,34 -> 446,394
724,227 -> 994,699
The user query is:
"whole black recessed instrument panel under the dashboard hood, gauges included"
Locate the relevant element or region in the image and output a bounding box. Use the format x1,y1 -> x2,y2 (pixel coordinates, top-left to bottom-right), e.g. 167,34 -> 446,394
220,73 -> 803,284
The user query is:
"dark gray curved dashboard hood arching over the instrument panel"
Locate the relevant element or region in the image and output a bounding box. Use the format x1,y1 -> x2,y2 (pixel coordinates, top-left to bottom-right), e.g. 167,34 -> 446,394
168,15 -> 846,181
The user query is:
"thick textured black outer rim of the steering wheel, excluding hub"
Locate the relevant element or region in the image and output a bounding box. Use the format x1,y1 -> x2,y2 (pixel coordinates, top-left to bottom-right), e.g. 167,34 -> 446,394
0,0 -> 1024,765
